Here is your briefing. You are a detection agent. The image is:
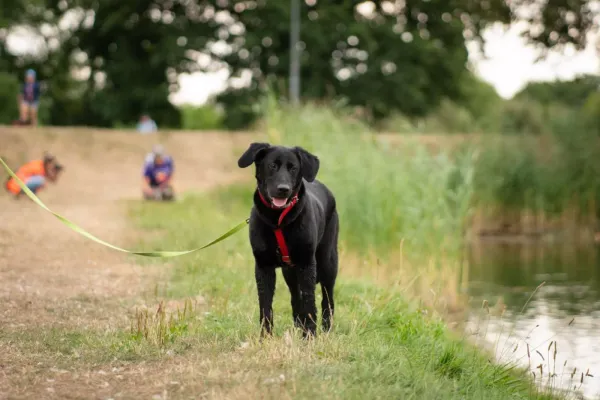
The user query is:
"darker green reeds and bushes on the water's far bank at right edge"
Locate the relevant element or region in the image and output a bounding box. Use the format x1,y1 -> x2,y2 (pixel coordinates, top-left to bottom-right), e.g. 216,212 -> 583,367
474,124 -> 600,218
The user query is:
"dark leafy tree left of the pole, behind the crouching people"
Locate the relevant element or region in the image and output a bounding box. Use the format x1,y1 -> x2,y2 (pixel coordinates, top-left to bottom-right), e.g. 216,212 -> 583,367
46,0 -> 223,127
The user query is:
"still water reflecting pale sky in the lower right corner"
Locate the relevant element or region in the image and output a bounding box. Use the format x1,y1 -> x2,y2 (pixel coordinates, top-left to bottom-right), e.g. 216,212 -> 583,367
463,242 -> 600,399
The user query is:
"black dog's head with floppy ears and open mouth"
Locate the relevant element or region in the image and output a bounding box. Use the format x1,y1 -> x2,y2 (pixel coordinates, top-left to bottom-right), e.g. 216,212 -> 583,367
238,143 -> 319,208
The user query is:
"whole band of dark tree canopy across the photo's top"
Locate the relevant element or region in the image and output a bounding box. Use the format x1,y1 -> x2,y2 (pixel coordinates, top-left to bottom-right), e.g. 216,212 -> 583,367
0,0 -> 597,127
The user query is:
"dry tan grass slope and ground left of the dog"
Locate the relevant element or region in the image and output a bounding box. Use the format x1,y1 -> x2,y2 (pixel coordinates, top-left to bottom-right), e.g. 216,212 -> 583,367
0,128 -> 255,399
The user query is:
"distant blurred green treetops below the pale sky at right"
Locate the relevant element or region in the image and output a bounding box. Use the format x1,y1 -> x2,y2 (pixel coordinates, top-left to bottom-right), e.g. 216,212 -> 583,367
377,74 -> 600,135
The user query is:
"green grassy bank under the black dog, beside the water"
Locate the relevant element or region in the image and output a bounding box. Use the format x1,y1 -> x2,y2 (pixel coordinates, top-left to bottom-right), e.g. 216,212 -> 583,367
120,185 -> 543,399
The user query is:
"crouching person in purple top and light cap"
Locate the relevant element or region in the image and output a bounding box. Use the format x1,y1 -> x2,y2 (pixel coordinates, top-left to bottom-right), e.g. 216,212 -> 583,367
142,145 -> 174,200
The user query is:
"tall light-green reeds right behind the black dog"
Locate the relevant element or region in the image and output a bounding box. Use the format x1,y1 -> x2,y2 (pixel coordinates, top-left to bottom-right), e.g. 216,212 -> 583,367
266,98 -> 475,261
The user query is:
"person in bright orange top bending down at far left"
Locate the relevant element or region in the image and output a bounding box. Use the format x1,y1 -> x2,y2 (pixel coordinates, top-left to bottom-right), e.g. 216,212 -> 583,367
5,153 -> 63,198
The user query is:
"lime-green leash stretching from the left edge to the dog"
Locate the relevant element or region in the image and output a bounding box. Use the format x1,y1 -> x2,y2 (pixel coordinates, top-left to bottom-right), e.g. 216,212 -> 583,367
0,157 -> 249,258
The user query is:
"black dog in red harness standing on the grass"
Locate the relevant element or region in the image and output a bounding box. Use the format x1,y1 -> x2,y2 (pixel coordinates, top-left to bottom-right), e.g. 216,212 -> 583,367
238,143 -> 339,337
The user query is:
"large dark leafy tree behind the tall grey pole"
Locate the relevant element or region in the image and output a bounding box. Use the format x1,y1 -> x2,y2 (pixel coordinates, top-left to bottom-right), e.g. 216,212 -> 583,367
213,0 -> 509,125
